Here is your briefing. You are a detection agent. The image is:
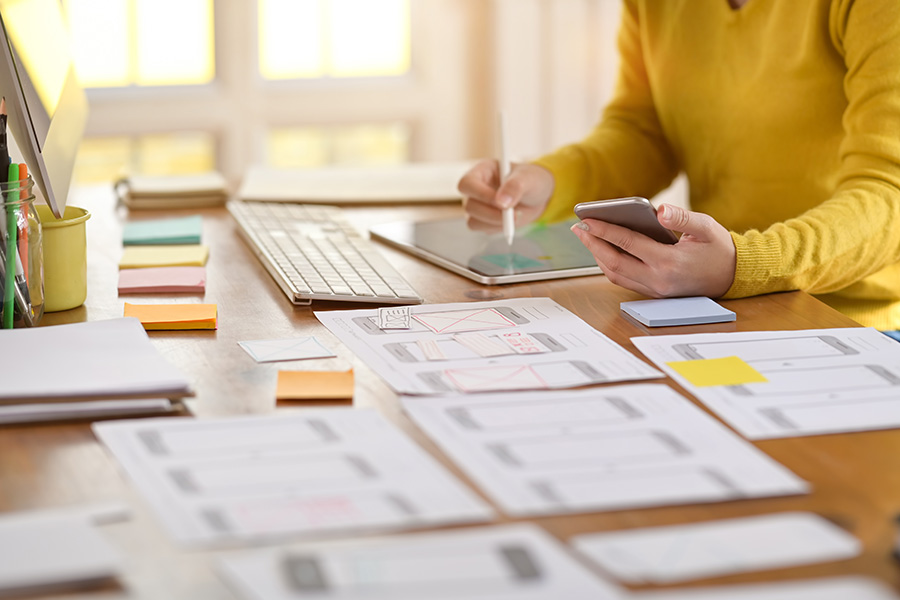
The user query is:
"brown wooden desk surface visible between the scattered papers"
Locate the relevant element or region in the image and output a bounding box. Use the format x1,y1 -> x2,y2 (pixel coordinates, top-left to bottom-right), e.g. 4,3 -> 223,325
0,188 -> 900,600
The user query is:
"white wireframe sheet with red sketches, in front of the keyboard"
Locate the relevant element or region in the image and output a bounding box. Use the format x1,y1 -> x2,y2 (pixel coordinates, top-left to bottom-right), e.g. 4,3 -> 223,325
315,298 -> 660,394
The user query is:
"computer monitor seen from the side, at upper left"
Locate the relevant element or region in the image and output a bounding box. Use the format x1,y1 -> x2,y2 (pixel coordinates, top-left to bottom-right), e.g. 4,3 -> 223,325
0,0 -> 88,218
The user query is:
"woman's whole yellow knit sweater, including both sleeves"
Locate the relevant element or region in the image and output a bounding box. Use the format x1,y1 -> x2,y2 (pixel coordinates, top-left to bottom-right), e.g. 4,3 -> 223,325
536,0 -> 900,329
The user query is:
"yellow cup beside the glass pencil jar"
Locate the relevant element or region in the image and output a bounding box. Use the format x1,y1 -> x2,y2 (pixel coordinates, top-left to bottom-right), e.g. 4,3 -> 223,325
35,204 -> 91,312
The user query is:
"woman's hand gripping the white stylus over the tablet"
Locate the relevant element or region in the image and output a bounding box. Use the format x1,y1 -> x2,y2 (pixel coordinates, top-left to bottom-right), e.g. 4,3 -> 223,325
457,160 -> 555,233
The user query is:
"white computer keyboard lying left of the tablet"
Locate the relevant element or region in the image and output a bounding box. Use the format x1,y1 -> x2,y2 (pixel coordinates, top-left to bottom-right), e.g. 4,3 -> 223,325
228,201 -> 422,304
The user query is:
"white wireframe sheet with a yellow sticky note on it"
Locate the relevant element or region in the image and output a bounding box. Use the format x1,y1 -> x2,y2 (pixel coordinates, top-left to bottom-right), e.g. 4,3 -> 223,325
632,327 -> 900,439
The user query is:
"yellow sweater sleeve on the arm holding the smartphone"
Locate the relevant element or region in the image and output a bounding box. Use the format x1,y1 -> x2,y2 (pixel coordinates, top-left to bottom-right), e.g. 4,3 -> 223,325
725,0 -> 900,298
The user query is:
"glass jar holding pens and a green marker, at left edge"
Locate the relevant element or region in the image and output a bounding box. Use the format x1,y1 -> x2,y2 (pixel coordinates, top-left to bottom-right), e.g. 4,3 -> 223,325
0,175 -> 44,329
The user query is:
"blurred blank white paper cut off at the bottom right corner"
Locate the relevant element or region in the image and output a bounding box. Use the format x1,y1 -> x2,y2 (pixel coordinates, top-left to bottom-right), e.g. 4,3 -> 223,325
630,577 -> 900,600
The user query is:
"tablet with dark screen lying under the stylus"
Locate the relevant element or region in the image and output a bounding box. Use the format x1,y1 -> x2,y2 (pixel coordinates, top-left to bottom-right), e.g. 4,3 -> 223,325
369,218 -> 602,285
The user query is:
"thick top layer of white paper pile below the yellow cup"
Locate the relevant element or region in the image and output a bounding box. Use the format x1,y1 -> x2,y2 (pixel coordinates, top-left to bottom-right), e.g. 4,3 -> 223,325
0,319 -> 190,403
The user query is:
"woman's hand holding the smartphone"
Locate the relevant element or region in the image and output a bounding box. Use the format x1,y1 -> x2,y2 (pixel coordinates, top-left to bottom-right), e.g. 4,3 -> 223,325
572,204 -> 735,298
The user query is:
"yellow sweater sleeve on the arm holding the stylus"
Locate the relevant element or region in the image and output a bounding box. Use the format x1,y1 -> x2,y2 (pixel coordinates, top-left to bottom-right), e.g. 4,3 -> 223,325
535,0 -> 678,221
